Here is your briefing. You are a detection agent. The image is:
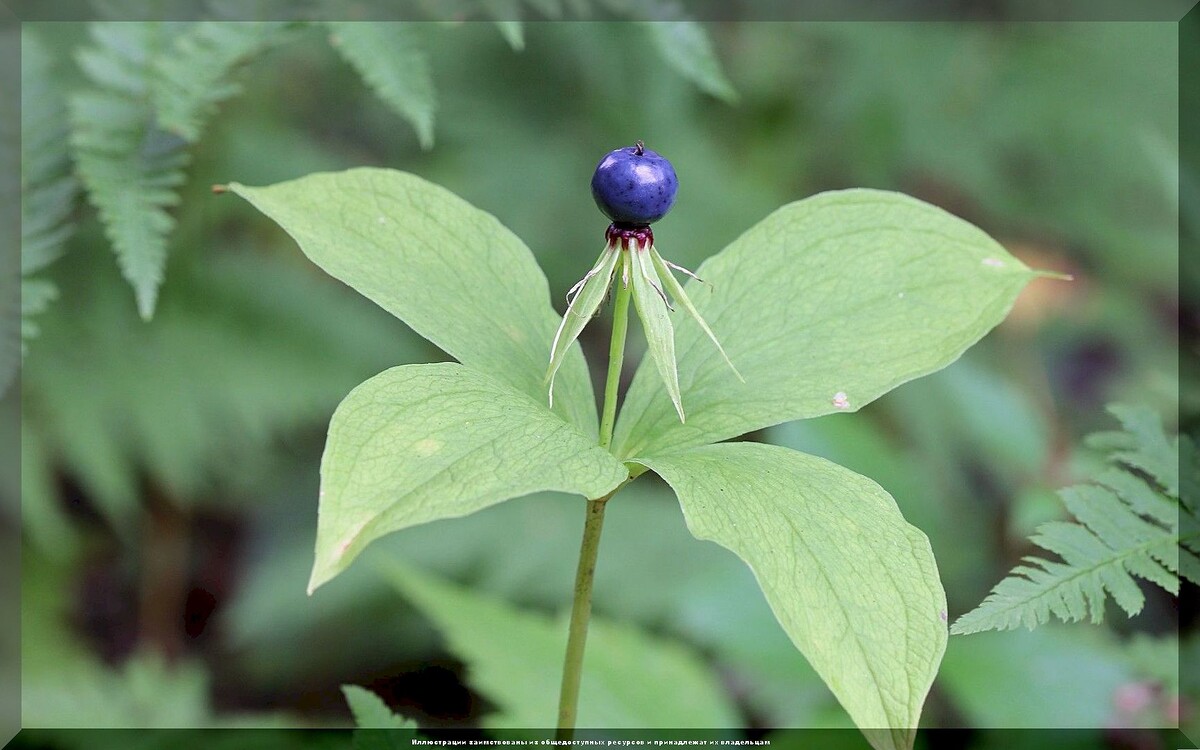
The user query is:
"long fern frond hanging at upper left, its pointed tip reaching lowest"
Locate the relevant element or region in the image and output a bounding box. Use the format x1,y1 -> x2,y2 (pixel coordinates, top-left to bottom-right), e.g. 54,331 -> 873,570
70,22 -> 188,319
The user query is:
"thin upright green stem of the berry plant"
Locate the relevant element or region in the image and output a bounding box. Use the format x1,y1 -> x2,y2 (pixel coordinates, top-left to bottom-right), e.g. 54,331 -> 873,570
556,258 -> 631,740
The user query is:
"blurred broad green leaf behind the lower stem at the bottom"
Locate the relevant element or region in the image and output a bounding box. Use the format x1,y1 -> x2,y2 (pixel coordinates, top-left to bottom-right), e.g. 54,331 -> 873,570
391,561 -> 738,730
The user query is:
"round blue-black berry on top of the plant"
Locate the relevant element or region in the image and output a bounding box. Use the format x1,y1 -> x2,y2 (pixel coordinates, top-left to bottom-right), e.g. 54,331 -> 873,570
592,140 -> 679,227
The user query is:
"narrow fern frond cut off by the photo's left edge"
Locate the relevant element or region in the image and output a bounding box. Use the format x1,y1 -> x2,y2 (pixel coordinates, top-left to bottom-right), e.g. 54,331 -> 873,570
20,29 -> 78,358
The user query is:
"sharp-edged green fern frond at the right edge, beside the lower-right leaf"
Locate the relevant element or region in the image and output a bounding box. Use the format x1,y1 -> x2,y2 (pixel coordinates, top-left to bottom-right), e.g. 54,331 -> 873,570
950,406 -> 1200,634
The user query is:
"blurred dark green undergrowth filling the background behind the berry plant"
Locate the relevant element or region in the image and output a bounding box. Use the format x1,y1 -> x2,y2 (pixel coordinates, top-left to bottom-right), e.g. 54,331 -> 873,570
20,13 -> 1185,746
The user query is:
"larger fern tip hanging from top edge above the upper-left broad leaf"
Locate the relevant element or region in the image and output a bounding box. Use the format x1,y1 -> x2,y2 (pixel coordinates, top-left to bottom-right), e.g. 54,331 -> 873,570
328,20 -> 437,149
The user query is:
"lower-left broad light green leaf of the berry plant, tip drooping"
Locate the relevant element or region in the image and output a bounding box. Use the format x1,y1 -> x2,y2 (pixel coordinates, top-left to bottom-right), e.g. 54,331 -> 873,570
308,362 -> 628,593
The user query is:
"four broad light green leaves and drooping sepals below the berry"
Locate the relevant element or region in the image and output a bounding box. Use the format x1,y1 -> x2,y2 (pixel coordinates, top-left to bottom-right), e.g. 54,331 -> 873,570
229,149 -> 1036,749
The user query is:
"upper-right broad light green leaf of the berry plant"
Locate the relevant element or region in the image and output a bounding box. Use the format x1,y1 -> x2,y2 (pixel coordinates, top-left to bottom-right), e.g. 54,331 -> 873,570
613,190 -> 1034,457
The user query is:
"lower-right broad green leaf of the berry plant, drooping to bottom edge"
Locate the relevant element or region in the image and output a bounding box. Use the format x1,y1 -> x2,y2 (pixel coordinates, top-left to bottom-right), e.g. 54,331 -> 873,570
638,443 -> 947,750
